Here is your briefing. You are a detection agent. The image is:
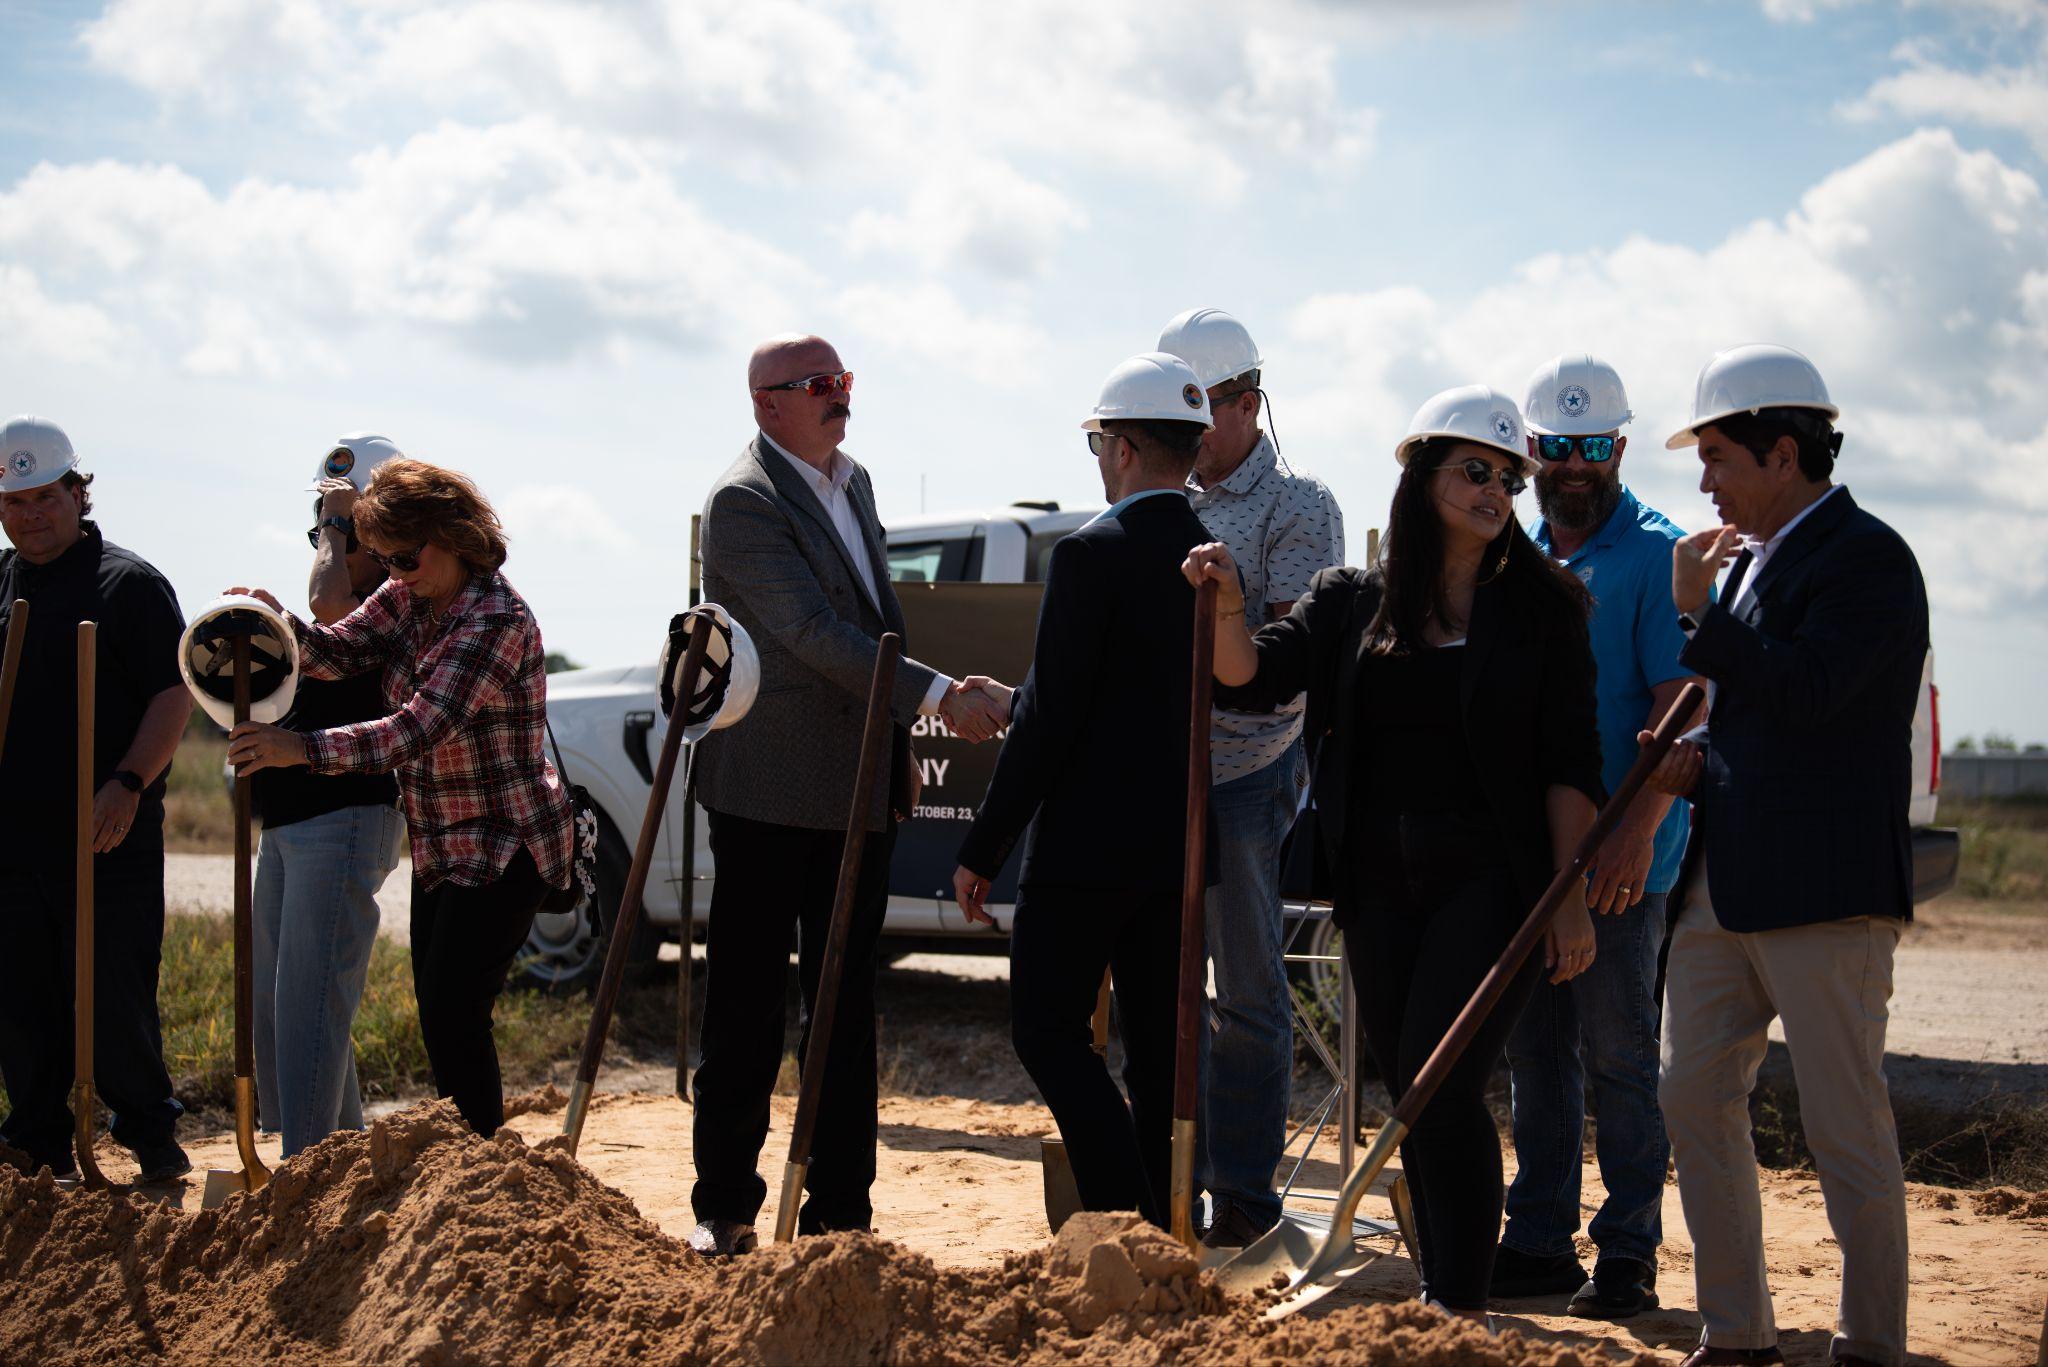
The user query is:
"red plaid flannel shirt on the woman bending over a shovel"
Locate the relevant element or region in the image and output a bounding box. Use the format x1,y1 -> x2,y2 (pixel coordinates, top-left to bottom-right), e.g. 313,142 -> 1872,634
293,574 -> 573,887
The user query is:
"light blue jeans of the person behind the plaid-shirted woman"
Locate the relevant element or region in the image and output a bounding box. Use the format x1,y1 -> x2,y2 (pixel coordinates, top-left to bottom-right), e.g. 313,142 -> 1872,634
252,805 -> 406,1158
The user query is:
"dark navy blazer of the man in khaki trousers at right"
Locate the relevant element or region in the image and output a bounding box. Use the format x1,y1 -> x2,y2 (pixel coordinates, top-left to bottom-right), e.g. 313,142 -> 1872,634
1679,490 -> 1927,930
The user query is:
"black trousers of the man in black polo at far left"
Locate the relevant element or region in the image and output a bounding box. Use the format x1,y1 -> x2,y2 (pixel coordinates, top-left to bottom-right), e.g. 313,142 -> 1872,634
0,851 -> 184,1170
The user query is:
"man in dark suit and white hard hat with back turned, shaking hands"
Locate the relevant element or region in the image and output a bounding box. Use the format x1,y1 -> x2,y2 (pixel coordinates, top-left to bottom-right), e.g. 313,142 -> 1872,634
952,353 -> 1210,1226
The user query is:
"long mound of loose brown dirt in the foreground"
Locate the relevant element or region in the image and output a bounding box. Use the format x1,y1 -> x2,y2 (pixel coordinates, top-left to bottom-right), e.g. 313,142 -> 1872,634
0,1103 -> 1638,1367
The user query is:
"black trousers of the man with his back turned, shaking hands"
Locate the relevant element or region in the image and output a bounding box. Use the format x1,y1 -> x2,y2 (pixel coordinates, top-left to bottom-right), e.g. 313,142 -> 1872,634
1010,887 -> 1180,1228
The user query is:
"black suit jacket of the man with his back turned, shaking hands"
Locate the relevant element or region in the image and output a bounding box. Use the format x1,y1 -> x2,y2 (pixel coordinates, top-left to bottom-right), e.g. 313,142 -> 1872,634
961,494 -> 1214,892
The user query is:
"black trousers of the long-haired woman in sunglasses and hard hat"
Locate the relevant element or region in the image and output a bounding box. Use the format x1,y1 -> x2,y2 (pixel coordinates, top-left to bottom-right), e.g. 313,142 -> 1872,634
1343,818 -> 1542,1310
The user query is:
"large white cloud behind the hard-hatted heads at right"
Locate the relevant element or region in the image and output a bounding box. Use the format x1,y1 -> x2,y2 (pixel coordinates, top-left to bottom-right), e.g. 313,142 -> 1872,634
1272,131 -> 2048,613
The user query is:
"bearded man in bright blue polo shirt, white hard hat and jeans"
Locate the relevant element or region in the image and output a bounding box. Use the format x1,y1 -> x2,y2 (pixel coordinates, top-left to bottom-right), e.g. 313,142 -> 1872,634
1493,355 -> 1690,1320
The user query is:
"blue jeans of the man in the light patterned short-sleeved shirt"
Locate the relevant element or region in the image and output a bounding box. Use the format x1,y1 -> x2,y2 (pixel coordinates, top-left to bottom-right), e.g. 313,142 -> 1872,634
1196,740 -> 1307,1226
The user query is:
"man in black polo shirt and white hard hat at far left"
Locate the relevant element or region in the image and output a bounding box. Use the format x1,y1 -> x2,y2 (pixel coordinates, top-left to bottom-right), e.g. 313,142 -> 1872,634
0,416 -> 193,1183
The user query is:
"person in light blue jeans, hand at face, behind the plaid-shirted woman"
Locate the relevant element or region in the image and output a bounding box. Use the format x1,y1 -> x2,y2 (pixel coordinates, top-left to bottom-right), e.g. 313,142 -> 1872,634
250,437 -> 403,1158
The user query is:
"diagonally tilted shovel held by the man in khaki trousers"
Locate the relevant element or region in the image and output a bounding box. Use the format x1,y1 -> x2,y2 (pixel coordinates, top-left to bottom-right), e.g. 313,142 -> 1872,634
1217,682 -> 1706,1320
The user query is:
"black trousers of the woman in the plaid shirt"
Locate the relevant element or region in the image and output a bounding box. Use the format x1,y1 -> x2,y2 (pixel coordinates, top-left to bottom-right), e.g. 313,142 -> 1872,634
412,851 -> 547,1137
